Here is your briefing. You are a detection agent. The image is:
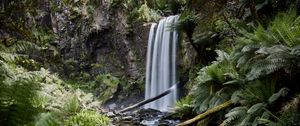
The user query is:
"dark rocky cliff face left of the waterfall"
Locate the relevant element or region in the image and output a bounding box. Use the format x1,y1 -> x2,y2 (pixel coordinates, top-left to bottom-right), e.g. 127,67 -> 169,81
51,0 -> 148,79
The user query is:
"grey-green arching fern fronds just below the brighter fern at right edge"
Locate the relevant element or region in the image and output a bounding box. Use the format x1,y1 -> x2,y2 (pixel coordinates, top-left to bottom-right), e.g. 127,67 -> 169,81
237,45 -> 299,80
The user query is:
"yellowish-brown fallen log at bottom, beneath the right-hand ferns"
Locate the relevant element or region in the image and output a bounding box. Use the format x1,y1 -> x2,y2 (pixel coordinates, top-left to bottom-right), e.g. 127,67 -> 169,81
177,100 -> 233,126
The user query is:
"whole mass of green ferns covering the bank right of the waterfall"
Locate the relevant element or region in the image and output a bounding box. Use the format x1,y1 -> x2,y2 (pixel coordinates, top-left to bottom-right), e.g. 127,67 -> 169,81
179,4 -> 300,126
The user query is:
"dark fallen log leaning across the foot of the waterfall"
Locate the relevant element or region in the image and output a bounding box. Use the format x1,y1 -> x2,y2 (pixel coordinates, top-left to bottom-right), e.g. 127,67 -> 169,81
120,84 -> 178,113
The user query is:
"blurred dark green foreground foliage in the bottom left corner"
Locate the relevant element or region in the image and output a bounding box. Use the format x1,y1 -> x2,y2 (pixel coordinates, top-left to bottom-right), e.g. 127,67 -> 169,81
0,60 -> 41,125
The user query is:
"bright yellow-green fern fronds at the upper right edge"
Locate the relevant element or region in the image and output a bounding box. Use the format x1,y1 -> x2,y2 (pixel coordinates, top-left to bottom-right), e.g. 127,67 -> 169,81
238,11 -> 300,47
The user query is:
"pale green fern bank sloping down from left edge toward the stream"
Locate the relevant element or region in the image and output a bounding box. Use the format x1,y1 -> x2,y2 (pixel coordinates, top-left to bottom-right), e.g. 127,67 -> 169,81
0,32 -> 110,126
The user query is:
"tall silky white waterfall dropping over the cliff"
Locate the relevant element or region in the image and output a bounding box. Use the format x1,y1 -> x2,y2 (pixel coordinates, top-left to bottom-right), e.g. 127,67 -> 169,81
145,15 -> 179,111
